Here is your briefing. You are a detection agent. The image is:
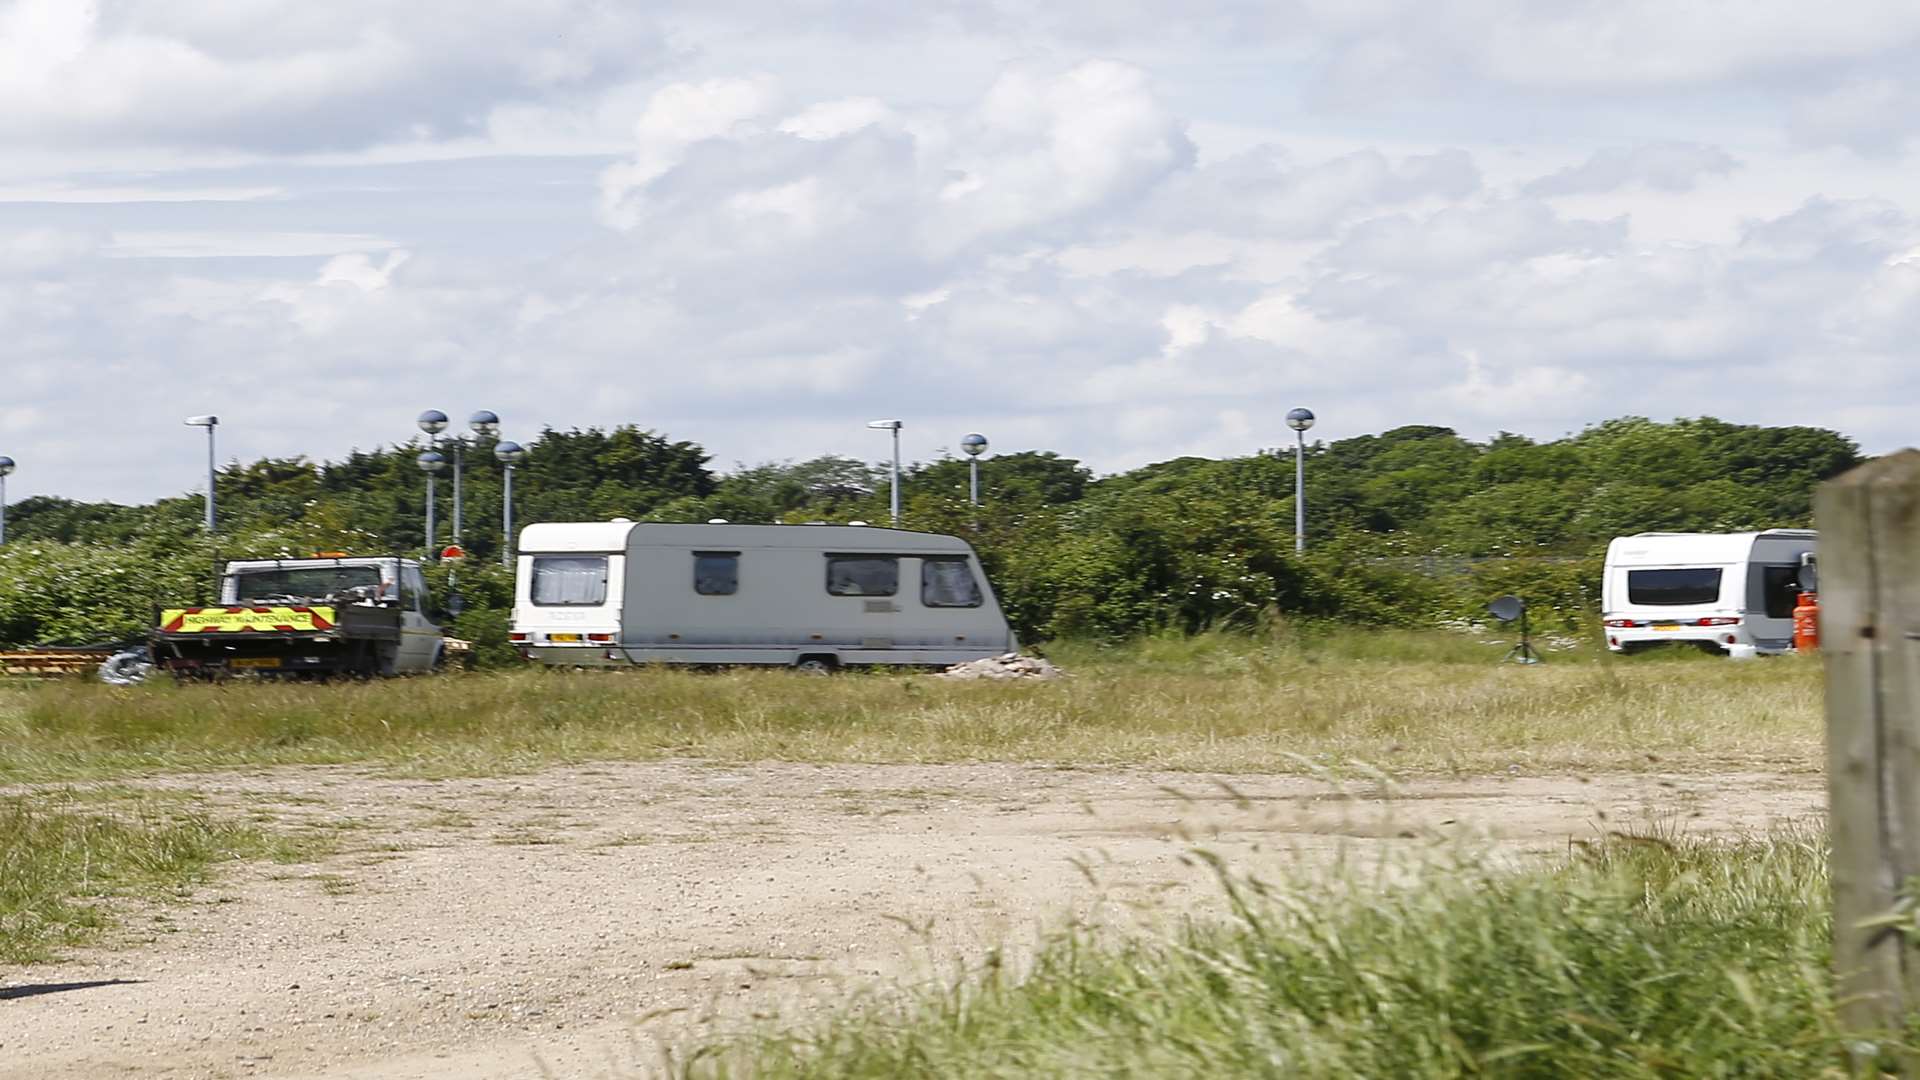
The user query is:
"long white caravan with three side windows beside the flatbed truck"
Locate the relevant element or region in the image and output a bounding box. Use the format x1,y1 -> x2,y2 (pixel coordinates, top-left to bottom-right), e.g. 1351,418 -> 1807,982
509,521 -> 1020,671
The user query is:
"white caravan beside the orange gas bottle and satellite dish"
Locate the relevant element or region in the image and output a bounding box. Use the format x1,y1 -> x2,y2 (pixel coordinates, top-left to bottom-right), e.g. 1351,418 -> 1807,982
1599,528 -> 1816,653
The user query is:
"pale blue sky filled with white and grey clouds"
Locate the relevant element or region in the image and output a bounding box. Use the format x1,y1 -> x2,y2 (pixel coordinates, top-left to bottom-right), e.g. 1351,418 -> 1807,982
0,0 -> 1920,502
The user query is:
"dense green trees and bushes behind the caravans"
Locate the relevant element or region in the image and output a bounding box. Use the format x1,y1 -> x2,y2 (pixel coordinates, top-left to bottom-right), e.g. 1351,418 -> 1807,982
0,417 -> 1862,657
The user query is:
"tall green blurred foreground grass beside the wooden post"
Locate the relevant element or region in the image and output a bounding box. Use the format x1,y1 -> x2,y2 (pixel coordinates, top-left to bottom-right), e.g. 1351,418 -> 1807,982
670,832 -> 1914,1080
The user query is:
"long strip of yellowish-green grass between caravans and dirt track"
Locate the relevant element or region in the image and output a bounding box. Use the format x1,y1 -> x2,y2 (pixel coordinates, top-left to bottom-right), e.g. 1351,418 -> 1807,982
0,632 -> 1822,782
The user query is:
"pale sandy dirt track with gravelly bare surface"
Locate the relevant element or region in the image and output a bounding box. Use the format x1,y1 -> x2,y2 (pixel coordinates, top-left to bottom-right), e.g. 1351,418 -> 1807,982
0,763 -> 1824,1080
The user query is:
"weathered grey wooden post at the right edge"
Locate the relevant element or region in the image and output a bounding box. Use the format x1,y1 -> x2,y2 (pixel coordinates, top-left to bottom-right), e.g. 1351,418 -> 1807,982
1814,450 -> 1920,1028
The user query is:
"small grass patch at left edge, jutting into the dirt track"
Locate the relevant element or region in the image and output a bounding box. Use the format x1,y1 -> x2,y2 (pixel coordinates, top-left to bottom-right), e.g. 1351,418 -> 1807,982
0,790 -> 296,965
